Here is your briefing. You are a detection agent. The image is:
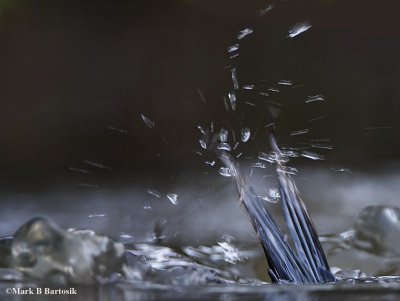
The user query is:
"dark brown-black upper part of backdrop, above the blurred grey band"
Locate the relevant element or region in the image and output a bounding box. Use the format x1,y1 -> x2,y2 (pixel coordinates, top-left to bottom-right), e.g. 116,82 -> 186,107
0,0 -> 400,191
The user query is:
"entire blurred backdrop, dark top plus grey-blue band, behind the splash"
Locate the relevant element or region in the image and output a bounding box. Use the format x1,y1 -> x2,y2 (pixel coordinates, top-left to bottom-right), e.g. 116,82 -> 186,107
0,0 -> 400,274
